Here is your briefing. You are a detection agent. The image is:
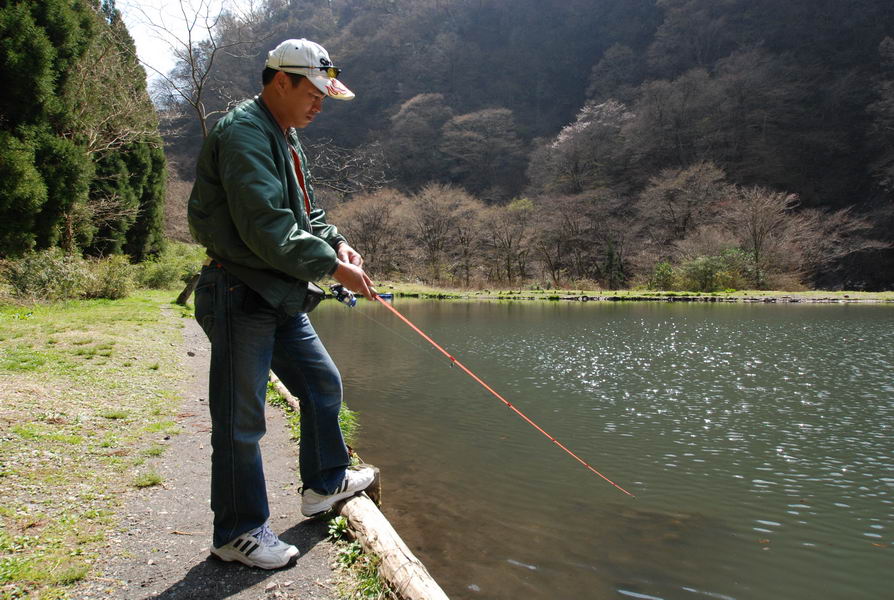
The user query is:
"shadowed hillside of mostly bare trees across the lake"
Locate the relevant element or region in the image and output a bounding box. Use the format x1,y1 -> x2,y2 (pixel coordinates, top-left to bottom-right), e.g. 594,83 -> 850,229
164,0 -> 894,289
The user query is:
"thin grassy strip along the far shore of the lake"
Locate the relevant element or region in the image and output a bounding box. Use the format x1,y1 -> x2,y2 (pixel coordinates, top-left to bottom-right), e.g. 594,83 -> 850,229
376,281 -> 894,302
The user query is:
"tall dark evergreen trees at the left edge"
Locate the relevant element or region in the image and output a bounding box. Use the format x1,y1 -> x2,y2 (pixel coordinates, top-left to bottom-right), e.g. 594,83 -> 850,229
0,0 -> 165,260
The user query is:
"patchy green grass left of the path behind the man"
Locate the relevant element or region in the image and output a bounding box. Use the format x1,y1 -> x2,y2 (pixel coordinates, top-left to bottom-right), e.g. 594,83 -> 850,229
0,291 -> 183,600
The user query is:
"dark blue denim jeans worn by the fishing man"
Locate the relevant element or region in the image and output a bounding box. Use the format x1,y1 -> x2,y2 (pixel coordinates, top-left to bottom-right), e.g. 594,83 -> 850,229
195,266 -> 349,547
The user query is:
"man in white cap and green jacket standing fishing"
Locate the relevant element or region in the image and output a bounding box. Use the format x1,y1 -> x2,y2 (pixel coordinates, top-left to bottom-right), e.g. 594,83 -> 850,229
188,39 -> 375,569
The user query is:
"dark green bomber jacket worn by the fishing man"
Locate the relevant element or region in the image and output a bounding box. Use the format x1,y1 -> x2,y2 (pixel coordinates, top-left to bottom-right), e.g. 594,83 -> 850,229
188,97 -> 345,314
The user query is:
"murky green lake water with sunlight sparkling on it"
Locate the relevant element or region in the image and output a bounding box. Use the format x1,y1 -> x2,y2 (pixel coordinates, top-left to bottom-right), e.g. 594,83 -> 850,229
312,299 -> 894,600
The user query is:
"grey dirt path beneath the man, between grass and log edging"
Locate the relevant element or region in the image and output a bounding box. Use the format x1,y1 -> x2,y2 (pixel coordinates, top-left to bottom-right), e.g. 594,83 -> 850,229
71,319 -> 337,600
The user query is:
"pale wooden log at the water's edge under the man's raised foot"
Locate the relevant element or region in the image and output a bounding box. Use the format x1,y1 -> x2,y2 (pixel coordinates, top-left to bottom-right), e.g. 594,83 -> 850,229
338,494 -> 447,600
